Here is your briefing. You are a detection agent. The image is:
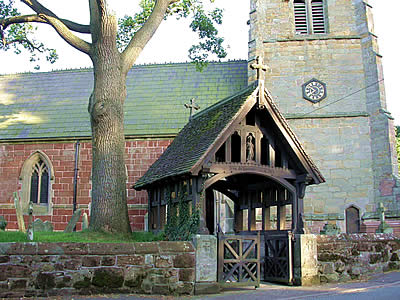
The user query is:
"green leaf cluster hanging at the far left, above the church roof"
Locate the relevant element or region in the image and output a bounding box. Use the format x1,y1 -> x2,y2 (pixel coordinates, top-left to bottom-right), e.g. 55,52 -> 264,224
0,0 -> 58,69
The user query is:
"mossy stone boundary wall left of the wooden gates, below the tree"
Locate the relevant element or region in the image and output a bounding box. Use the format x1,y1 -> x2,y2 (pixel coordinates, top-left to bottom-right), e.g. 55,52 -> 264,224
0,242 -> 196,298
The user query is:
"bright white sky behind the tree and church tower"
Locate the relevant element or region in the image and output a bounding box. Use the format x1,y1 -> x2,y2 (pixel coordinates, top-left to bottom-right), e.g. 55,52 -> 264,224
0,0 -> 400,125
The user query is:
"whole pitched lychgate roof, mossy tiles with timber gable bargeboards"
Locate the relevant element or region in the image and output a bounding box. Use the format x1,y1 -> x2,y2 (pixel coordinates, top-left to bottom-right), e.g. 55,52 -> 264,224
134,84 -> 325,189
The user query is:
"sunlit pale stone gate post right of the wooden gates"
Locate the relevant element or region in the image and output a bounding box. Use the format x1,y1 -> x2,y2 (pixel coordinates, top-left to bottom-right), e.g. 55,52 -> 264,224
293,234 -> 320,285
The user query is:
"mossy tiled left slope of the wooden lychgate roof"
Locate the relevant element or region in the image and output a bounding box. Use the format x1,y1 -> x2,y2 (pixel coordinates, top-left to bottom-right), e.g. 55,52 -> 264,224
134,85 -> 257,189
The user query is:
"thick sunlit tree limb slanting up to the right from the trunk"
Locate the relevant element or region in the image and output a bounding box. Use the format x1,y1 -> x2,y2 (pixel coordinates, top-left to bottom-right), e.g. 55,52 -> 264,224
122,0 -> 178,72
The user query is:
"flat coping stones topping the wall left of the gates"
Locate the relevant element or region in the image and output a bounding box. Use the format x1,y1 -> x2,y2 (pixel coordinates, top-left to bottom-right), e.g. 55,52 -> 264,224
0,241 -> 195,255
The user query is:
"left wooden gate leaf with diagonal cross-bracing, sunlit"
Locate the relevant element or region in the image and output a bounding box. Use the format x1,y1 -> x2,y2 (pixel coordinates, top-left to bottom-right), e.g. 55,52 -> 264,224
218,233 -> 260,287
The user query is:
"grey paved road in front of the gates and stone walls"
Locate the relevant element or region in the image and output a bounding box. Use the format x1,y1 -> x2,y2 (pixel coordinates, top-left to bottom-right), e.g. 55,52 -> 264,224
69,272 -> 400,300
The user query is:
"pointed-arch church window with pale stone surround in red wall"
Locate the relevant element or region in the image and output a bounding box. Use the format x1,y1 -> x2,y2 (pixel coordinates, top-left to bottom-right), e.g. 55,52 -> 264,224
20,151 -> 54,215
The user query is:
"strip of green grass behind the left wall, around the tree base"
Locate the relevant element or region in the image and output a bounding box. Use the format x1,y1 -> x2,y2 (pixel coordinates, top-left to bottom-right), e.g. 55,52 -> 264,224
0,231 -> 164,243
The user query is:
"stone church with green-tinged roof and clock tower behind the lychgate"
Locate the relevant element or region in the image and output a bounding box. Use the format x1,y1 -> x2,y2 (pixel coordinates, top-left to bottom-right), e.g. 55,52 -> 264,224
0,0 -> 400,233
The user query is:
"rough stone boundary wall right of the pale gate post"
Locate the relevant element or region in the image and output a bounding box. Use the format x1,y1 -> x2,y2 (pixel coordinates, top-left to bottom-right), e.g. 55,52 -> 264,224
317,234 -> 400,283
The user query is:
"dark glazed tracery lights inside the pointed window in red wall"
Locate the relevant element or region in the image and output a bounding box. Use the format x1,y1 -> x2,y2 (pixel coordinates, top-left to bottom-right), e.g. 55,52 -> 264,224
30,159 -> 50,204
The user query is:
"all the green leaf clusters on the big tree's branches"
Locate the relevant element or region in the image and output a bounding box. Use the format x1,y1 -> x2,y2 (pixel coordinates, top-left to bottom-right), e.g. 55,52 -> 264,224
0,0 -> 227,70
